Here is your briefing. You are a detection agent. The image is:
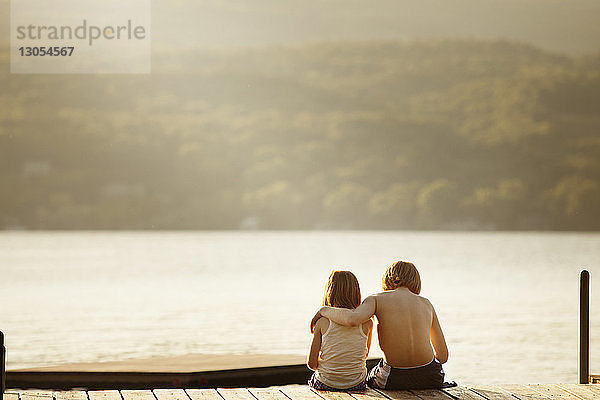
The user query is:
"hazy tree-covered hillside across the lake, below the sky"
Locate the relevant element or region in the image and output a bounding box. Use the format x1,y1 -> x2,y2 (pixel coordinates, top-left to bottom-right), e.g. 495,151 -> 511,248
0,41 -> 600,230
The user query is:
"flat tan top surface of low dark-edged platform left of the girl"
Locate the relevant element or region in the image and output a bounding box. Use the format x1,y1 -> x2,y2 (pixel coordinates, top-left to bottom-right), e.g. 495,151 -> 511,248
9,354 -> 306,373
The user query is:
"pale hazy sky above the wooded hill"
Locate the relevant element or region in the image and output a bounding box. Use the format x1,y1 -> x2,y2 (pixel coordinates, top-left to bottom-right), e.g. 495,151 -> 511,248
0,0 -> 600,54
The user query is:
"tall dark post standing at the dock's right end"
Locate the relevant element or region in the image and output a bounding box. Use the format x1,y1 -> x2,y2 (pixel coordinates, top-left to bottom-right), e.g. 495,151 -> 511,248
577,269 -> 590,383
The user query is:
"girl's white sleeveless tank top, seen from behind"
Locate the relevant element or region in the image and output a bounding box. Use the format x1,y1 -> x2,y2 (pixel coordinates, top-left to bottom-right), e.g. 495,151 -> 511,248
316,320 -> 367,389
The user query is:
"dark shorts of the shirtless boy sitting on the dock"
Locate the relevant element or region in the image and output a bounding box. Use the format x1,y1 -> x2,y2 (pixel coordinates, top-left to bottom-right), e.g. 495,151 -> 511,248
367,359 -> 444,389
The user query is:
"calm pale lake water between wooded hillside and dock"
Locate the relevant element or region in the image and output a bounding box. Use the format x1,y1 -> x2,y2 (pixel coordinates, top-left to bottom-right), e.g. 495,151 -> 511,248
0,232 -> 600,383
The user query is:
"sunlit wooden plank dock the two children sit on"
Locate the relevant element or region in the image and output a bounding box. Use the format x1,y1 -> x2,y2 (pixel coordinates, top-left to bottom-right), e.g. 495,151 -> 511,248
4,384 -> 600,400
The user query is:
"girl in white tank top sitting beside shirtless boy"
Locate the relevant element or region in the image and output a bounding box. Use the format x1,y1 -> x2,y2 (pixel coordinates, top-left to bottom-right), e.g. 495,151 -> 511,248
306,271 -> 373,390
